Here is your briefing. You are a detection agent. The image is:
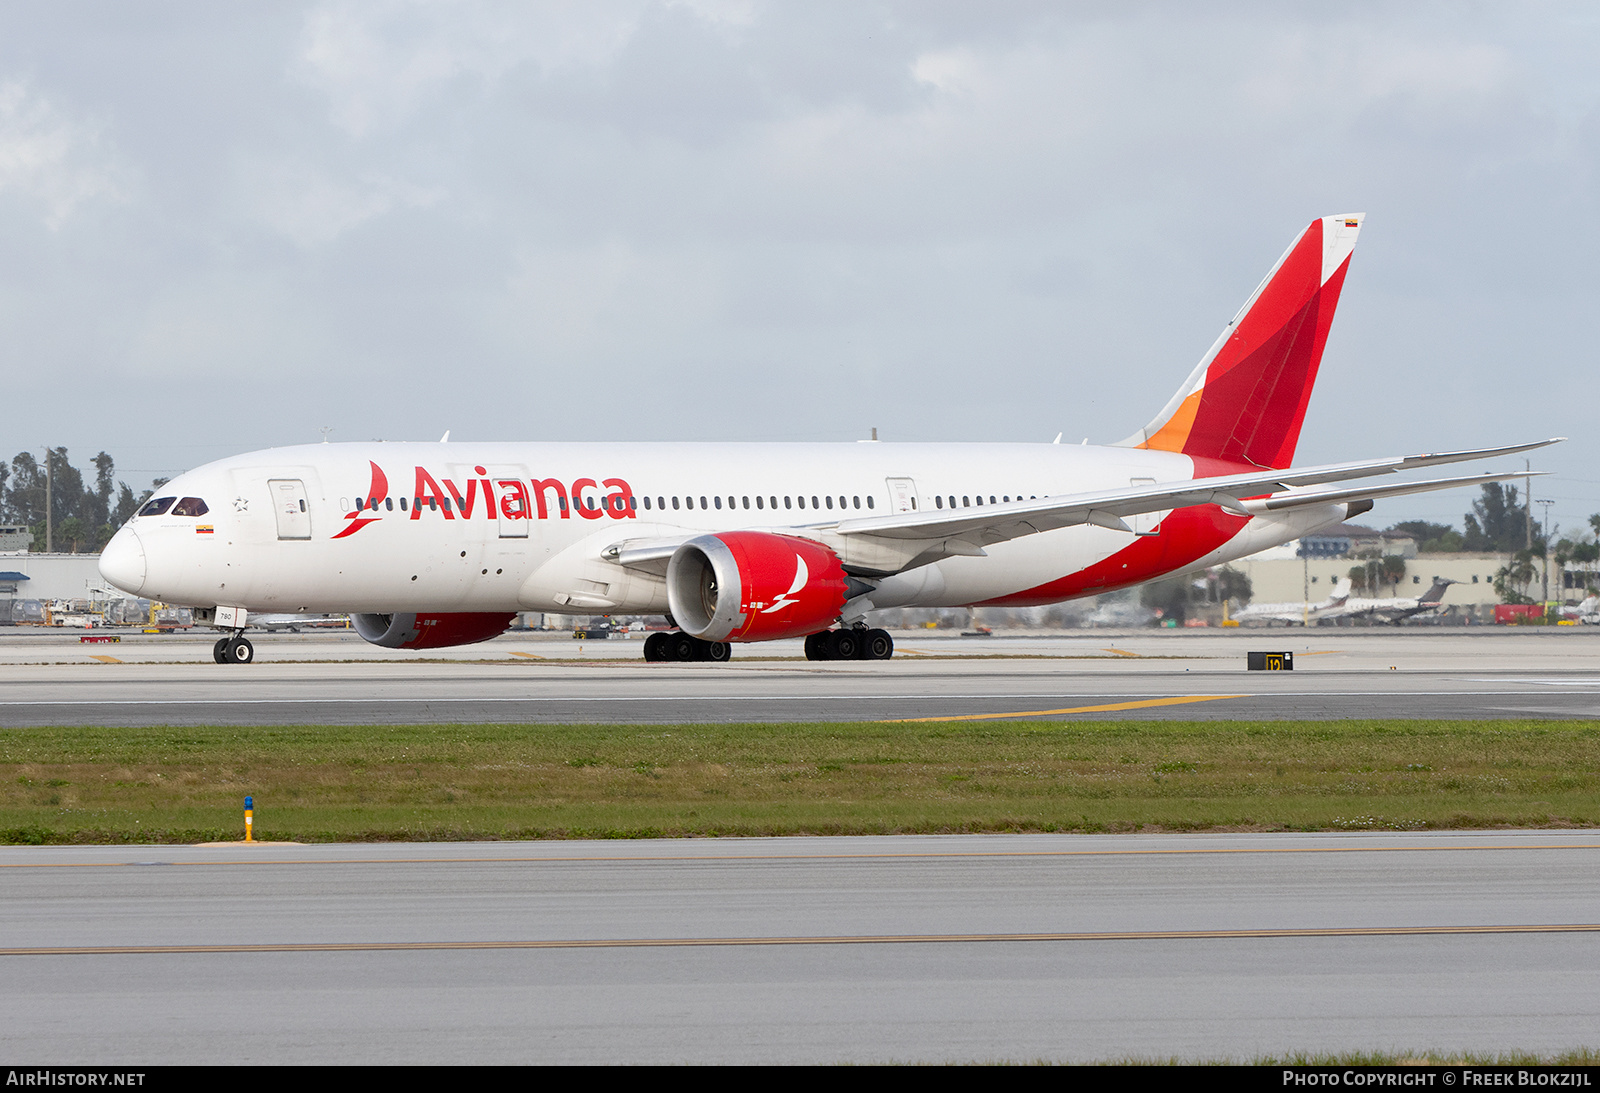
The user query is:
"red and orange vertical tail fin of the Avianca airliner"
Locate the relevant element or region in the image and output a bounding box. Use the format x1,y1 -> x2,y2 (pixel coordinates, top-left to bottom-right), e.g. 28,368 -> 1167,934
1122,213 -> 1363,467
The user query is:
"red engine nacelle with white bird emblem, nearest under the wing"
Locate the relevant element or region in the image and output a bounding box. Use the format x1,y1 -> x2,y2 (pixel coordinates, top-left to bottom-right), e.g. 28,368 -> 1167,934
667,531 -> 850,642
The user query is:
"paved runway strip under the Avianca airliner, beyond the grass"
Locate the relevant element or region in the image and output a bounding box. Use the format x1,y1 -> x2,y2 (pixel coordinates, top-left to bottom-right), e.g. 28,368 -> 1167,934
0,627 -> 1600,727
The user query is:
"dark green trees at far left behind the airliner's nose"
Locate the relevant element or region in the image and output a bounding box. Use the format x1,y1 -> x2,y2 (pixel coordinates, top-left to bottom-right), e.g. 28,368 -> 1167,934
0,448 -> 166,554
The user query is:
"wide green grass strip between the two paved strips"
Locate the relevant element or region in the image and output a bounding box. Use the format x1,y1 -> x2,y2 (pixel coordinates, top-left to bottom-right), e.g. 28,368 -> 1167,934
0,720 -> 1600,843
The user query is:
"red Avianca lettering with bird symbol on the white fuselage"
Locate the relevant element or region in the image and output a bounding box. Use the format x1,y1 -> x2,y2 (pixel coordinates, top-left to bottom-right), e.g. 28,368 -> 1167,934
333,461 -> 638,539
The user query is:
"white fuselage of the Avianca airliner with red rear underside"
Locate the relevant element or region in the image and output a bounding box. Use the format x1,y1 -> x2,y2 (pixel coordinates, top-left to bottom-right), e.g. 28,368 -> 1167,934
102,443 -> 1346,627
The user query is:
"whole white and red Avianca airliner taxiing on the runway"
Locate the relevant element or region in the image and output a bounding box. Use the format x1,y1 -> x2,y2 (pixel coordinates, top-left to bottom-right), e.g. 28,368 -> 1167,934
101,214 -> 1554,663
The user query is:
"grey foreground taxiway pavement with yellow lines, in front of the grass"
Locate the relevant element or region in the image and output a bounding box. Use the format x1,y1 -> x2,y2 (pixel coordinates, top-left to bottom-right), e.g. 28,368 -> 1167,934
0,831 -> 1600,1064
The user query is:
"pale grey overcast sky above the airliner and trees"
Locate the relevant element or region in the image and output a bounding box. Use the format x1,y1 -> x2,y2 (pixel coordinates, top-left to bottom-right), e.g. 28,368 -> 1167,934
0,0 -> 1600,528
